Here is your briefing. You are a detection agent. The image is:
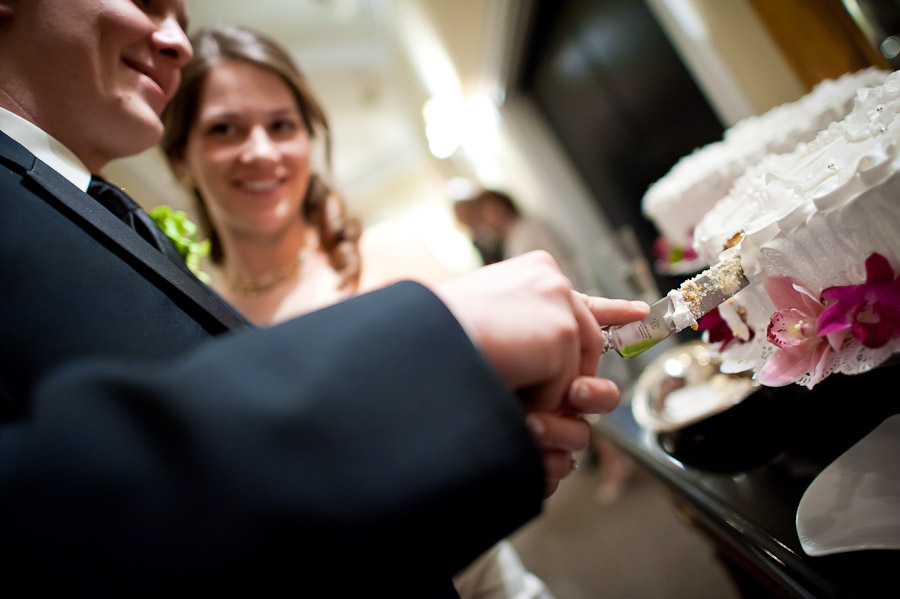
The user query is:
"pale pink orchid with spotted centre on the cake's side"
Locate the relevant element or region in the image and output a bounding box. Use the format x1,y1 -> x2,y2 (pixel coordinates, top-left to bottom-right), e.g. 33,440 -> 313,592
759,276 -> 845,387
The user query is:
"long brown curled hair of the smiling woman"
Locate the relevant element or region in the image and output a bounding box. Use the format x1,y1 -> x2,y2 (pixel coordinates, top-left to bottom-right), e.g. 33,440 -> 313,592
161,25 -> 360,283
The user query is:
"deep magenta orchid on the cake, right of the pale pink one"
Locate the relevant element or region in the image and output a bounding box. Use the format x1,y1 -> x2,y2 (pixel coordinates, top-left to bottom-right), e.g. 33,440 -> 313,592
818,253 -> 900,348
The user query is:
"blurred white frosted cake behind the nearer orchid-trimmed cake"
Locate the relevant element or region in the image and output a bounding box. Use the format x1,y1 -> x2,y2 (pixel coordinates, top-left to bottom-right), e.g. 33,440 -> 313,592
642,68 -> 889,264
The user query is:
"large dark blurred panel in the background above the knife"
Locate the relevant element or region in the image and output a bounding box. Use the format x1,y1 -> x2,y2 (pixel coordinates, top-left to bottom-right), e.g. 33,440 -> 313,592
519,0 -> 723,292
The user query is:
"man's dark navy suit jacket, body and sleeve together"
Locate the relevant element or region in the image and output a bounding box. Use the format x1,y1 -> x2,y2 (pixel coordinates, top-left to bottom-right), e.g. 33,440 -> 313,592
0,133 -> 543,597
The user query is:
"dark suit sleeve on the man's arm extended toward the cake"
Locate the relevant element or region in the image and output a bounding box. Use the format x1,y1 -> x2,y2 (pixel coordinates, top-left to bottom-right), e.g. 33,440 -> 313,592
0,283 -> 543,593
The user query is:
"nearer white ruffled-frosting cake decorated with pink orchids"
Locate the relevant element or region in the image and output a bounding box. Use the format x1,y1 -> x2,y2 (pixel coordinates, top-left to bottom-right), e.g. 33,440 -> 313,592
694,71 -> 900,387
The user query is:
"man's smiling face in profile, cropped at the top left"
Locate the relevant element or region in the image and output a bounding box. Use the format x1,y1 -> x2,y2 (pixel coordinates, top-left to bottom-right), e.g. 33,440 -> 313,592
1,0 -> 191,171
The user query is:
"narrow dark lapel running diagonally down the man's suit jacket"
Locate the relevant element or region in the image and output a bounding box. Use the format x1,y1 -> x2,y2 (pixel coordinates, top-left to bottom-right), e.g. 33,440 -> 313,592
0,132 -> 252,333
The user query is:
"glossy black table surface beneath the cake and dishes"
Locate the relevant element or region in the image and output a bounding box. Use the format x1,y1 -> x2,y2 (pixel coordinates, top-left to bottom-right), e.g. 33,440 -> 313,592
596,363 -> 900,598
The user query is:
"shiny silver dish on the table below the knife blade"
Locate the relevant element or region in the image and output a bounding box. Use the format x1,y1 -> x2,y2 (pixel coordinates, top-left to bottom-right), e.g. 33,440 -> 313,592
631,341 -> 758,432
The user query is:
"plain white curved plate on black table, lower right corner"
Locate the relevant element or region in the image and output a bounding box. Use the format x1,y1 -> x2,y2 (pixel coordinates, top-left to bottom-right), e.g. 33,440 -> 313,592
797,414 -> 900,556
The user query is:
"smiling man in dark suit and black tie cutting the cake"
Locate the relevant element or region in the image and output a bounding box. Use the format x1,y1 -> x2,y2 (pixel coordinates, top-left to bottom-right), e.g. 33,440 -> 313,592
0,0 -> 646,597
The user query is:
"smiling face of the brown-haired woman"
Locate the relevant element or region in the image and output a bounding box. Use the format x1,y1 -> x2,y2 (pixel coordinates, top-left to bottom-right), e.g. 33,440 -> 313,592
184,60 -> 310,241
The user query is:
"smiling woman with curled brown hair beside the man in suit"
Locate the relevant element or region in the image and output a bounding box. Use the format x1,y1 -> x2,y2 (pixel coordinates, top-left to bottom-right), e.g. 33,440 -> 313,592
162,25 -> 552,599
